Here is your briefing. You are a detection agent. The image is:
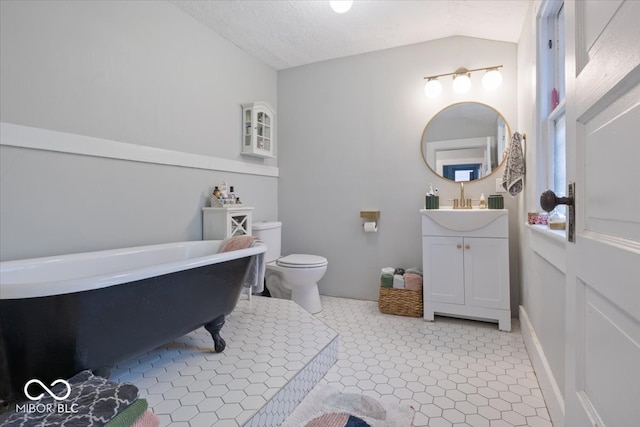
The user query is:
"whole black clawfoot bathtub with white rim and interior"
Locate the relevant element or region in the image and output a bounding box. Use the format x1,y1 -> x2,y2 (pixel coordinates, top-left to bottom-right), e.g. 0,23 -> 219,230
0,240 -> 266,401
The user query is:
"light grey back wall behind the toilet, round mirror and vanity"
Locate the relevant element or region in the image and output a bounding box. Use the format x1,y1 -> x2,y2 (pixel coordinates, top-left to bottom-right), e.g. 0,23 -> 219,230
278,37 -> 519,304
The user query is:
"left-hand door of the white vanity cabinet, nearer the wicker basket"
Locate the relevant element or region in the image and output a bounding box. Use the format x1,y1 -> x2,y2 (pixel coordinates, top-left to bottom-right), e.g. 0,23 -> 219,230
422,236 -> 465,305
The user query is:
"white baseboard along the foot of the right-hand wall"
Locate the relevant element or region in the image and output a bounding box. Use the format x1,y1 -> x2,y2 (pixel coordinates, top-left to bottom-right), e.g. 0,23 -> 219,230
519,306 -> 564,427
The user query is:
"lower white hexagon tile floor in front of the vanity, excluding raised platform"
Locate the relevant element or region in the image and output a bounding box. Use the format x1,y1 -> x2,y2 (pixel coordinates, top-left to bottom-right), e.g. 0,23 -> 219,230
317,297 -> 551,427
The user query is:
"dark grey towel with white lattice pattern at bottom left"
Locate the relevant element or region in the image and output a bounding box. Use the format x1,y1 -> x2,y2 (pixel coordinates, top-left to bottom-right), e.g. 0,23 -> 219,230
0,371 -> 138,427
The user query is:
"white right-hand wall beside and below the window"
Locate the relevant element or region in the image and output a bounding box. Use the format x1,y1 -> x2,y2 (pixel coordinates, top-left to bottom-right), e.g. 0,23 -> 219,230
517,3 -> 565,426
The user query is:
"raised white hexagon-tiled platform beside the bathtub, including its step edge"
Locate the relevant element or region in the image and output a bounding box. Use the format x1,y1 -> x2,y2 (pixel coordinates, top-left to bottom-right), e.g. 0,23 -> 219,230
111,297 -> 338,427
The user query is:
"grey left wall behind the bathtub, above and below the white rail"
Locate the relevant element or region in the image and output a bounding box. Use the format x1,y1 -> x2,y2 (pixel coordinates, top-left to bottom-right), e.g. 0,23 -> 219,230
0,0 -> 278,260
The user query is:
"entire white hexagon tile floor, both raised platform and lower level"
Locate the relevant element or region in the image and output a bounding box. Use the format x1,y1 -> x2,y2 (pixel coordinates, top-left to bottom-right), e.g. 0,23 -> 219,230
112,297 -> 552,427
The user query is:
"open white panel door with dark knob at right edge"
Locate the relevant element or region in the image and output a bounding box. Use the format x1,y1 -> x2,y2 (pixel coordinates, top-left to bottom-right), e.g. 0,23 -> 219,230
565,0 -> 640,427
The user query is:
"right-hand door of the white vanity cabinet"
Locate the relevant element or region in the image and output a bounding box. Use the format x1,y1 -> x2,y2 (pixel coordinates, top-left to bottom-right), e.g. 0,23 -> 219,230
464,237 -> 509,309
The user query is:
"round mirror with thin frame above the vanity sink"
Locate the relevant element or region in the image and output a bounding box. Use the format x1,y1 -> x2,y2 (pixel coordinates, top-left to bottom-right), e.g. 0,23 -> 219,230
421,102 -> 511,181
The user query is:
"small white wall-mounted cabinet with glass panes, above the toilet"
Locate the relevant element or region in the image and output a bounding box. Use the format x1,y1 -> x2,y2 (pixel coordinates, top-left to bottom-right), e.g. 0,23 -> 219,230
241,102 -> 276,157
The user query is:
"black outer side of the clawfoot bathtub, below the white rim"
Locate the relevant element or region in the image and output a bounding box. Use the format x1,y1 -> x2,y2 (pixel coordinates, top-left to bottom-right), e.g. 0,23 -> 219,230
0,257 -> 251,402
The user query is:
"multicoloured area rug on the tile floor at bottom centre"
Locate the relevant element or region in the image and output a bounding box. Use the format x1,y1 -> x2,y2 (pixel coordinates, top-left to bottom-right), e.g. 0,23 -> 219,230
281,385 -> 415,427
